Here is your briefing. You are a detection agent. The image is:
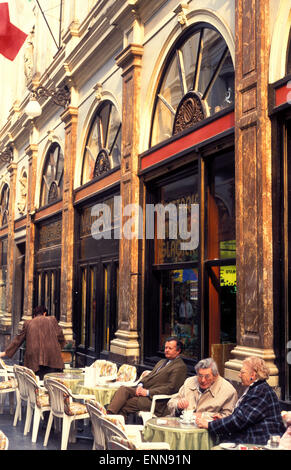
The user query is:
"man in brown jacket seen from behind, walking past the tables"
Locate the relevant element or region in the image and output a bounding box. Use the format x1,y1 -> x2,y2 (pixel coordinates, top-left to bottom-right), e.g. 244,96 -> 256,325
0,306 -> 66,380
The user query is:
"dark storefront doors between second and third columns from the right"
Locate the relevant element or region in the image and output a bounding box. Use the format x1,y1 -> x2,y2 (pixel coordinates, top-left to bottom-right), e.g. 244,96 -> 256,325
73,196 -> 119,366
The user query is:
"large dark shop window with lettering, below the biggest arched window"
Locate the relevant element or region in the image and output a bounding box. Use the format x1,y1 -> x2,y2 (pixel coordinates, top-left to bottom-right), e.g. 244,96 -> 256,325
145,151 -> 236,361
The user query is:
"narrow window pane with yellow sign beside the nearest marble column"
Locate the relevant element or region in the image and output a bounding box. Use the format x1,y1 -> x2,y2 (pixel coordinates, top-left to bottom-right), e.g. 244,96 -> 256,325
205,154 -> 236,352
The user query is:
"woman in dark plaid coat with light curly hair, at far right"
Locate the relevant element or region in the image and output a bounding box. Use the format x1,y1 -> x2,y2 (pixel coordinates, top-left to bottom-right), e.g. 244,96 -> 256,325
196,357 -> 284,445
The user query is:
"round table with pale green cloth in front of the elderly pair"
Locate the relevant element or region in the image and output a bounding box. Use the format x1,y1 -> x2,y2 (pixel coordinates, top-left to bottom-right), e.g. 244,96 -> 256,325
143,416 -> 215,450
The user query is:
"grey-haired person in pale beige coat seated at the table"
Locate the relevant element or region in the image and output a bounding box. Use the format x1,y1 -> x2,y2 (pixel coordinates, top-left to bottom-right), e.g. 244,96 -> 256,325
167,357 -> 237,416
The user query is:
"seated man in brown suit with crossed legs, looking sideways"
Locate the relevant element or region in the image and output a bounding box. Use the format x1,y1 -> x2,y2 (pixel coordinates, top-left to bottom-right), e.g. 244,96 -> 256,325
107,337 -> 187,418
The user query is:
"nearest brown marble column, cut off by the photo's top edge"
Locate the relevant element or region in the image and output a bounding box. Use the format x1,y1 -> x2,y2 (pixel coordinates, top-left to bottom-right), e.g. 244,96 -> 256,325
225,0 -> 278,386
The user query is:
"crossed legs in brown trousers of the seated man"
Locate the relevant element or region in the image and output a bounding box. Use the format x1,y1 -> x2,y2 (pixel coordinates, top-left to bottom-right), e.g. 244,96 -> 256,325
107,386 -> 152,419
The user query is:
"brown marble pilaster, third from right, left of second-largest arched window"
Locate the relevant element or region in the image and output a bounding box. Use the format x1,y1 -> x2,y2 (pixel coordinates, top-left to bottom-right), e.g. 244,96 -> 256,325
60,106 -> 78,340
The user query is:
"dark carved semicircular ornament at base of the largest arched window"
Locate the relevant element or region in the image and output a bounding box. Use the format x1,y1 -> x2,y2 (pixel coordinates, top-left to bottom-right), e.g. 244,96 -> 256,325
173,91 -> 206,135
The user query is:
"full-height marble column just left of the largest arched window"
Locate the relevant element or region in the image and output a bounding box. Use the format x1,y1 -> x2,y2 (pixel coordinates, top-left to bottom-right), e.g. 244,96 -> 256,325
110,44 -> 143,363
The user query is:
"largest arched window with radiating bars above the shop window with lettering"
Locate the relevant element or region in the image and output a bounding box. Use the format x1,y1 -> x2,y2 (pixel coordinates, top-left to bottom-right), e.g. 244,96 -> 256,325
150,24 -> 234,146
